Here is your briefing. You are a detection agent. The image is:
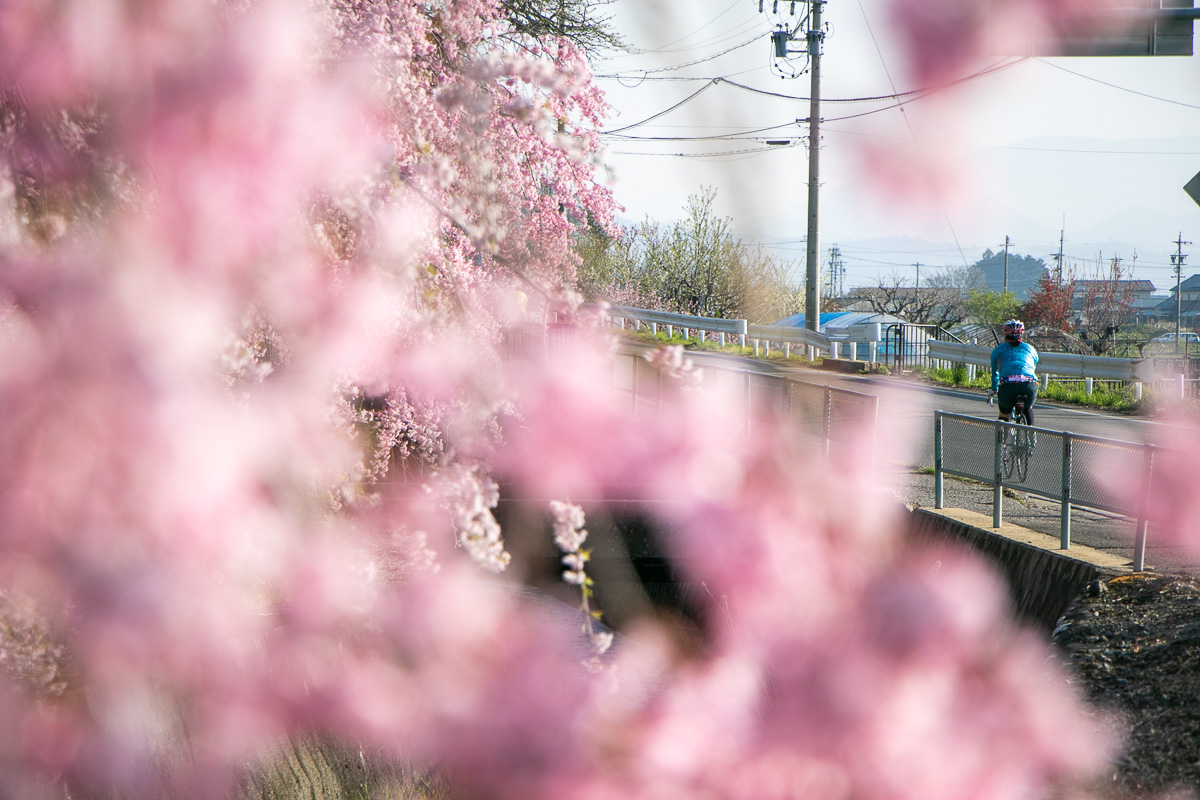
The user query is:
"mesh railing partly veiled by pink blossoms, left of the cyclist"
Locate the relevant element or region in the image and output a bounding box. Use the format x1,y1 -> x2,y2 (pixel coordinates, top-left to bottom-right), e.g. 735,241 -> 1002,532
613,353 -> 880,462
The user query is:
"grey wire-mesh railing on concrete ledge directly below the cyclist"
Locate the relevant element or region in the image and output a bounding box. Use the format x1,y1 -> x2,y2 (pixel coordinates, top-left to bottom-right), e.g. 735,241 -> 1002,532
934,411 -> 1159,571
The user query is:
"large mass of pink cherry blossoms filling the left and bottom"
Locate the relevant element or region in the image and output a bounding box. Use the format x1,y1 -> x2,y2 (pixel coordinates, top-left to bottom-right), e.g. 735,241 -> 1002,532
0,0 -> 1171,800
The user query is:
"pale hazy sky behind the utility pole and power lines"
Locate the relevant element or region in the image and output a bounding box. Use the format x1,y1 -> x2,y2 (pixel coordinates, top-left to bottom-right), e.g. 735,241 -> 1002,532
596,0 -> 1200,289
